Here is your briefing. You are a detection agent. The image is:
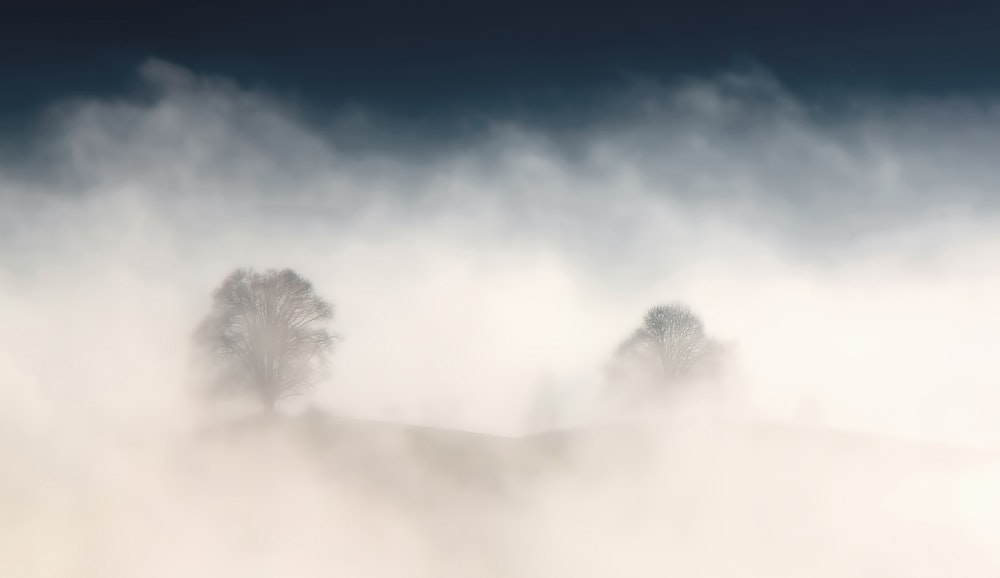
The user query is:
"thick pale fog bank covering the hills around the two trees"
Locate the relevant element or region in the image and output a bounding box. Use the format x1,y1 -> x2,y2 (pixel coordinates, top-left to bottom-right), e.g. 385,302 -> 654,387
0,61 -> 1000,578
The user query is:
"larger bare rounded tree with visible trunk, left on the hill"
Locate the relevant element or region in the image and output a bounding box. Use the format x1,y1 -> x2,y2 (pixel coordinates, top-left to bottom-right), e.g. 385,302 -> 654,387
197,269 -> 335,410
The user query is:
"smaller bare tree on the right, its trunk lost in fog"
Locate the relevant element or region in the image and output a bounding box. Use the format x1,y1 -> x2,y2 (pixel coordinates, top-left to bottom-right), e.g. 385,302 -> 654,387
616,303 -> 719,382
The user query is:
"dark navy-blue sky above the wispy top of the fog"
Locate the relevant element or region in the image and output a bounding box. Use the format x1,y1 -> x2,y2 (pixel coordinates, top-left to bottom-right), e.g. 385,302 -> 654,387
0,0 -> 1000,117
